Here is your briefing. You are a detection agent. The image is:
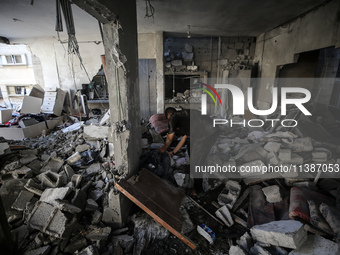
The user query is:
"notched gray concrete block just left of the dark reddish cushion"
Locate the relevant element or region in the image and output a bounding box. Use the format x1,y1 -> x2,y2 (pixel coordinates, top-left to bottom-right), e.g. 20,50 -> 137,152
217,180 -> 241,210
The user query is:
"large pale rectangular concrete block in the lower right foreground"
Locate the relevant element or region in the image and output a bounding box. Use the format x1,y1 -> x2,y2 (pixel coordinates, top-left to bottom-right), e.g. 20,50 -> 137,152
250,220 -> 307,249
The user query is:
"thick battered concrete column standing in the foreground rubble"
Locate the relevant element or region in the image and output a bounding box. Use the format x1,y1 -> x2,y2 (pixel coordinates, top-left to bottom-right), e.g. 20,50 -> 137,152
103,0 -> 141,225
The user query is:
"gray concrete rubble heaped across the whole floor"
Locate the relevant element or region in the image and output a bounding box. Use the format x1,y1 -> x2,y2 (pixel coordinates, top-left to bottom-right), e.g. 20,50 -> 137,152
0,110 -> 340,255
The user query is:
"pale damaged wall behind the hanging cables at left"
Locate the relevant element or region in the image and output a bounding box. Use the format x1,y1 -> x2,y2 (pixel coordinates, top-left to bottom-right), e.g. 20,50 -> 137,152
10,35 -> 104,90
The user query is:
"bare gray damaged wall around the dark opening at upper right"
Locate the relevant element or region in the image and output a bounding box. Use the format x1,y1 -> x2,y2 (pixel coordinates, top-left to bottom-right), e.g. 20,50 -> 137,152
255,0 -> 340,109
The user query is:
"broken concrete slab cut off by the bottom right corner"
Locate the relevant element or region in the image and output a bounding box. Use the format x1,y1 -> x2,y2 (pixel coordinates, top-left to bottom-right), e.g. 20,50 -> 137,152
289,235 -> 340,255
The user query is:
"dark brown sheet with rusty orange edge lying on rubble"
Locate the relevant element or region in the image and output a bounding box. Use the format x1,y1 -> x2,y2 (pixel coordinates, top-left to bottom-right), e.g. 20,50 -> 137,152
116,169 -> 196,249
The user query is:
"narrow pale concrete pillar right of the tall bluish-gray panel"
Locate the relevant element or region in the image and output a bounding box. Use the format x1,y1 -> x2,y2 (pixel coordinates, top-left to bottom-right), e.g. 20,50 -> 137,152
156,31 -> 165,113
